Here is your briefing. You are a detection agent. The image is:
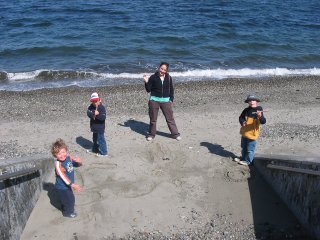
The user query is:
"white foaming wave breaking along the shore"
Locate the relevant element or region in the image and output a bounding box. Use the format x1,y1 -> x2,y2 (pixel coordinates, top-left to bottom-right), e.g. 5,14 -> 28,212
0,68 -> 320,91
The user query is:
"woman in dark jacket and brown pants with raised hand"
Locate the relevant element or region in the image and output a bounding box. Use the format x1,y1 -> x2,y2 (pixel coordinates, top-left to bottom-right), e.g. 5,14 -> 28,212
143,62 -> 181,141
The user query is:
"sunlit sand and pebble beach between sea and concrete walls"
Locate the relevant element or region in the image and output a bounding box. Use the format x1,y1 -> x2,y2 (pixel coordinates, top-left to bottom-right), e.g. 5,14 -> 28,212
0,77 -> 320,240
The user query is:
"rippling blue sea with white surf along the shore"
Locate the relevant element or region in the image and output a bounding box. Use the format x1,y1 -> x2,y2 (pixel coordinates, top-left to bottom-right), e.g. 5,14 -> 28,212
0,0 -> 320,91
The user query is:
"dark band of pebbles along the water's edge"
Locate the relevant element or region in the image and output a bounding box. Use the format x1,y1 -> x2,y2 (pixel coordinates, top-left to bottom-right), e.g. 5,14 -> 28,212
0,76 -> 320,120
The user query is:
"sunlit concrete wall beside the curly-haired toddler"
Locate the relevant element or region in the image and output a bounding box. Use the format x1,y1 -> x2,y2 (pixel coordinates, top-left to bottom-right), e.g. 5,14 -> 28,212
0,156 -> 54,240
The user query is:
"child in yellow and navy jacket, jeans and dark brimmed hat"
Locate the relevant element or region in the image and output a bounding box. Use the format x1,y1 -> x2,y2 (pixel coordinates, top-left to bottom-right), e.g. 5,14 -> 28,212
234,94 -> 266,166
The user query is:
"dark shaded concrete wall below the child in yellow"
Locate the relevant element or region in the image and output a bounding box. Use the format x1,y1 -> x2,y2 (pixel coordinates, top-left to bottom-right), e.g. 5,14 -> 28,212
254,154 -> 320,239
